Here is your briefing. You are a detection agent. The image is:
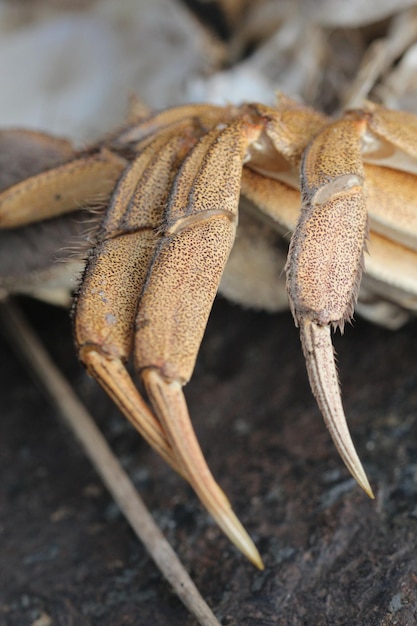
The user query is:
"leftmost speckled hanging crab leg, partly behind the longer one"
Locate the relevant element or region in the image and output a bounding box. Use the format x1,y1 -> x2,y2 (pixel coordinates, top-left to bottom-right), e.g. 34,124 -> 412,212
74,128 -> 200,473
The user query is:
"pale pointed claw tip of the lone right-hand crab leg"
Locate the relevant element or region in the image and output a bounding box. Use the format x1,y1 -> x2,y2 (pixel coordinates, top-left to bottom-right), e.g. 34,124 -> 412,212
300,319 -> 374,498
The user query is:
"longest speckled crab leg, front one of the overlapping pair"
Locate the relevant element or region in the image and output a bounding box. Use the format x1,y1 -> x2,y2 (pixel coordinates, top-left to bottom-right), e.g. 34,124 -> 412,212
135,121 -> 263,568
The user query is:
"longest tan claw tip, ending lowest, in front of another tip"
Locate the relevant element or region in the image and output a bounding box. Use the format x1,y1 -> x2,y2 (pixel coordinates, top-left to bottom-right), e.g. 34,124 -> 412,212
142,369 -> 264,570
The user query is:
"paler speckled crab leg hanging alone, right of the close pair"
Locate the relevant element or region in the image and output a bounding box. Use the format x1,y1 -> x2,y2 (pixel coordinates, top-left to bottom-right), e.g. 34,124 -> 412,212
287,111 -> 373,497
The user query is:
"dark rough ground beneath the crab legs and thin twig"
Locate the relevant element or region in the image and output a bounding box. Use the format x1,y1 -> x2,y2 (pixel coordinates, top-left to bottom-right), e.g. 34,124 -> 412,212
0,301 -> 417,626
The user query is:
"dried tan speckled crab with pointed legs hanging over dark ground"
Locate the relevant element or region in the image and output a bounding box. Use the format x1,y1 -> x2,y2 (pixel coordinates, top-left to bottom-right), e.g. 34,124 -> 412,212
0,95 -> 417,569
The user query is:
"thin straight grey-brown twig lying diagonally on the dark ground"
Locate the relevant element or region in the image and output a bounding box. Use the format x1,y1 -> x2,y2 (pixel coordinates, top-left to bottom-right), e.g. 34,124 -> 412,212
0,301 -> 220,626
